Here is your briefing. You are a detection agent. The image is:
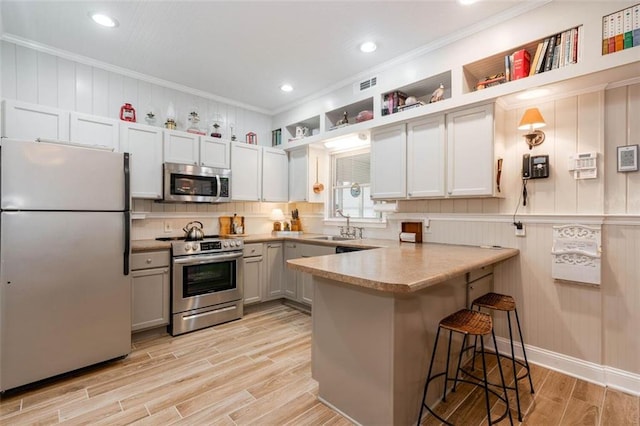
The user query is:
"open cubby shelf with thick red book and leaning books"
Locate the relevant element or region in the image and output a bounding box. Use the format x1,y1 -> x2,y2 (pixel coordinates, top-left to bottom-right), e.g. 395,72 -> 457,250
463,25 -> 583,93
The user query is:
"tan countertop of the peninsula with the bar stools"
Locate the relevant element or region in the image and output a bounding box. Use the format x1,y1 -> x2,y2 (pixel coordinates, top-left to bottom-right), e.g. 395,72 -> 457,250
287,240 -> 519,293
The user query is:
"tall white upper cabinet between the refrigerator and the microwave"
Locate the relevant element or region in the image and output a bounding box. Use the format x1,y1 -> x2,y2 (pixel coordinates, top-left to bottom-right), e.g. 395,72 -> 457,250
120,121 -> 163,200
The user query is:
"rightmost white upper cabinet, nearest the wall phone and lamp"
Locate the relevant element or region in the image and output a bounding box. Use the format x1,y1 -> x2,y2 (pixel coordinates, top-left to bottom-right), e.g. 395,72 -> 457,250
447,104 -> 494,197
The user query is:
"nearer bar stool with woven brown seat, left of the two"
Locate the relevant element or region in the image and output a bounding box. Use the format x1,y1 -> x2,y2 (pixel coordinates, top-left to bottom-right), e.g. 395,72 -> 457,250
418,309 -> 513,425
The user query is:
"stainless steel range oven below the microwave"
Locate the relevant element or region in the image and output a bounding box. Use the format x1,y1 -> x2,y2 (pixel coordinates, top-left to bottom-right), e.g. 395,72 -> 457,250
162,236 -> 244,336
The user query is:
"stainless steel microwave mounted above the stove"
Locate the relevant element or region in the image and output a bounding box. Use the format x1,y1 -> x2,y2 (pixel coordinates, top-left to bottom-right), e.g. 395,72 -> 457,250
164,163 -> 231,203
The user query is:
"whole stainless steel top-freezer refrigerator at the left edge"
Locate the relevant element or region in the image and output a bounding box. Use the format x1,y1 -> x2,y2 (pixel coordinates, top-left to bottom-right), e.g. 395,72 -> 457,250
0,139 -> 131,391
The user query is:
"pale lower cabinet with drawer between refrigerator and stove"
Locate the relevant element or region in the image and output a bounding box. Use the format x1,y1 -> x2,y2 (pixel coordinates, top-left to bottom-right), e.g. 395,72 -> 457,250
131,250 -> 170,331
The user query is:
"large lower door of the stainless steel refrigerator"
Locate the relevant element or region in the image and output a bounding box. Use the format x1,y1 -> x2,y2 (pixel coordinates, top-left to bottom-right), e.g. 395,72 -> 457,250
0,212 -> 131,390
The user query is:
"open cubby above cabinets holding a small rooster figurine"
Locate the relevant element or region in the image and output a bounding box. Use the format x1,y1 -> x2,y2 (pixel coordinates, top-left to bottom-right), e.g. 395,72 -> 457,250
380,71 -> 451,115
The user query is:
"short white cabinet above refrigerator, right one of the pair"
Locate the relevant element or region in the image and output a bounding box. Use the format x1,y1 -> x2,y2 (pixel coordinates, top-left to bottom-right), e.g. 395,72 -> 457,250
69,112 -> 120,151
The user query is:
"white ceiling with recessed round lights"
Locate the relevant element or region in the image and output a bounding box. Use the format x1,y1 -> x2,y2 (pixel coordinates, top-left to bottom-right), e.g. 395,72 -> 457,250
0,0 -> 548,113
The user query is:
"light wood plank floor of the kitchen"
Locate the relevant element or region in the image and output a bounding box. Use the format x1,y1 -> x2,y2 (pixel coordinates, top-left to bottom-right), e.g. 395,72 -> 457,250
0,304 -> 640,425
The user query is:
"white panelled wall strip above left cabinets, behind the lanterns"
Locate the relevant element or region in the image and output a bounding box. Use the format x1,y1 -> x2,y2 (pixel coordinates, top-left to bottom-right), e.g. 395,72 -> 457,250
0,41 -> 271,146
